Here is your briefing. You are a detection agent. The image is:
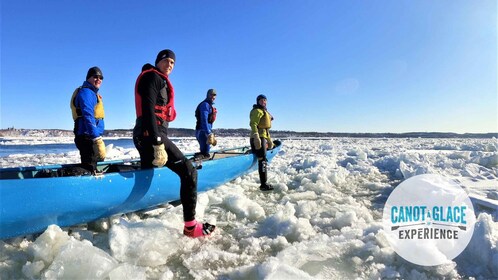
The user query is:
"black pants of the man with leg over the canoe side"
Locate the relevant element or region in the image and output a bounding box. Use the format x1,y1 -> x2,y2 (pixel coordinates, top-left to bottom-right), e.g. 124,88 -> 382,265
133,134 -> 197,222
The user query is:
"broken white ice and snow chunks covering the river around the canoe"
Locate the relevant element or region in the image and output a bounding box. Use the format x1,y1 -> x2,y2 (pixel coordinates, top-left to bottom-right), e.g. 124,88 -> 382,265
0,138 -> 498,279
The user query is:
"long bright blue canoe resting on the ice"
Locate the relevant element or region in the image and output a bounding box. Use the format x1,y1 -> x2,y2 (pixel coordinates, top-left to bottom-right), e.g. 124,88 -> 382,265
0,140 -> 282,239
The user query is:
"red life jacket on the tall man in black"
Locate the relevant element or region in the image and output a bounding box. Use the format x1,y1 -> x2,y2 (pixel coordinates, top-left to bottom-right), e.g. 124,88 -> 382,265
135,68 -> 176,125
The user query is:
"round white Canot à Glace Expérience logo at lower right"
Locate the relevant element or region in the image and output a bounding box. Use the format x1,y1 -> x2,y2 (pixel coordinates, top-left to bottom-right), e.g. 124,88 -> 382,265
383,174 -> 476,266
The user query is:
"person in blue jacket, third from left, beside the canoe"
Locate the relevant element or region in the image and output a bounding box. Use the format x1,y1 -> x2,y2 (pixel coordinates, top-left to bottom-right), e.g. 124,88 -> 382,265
195,89 -> 218,158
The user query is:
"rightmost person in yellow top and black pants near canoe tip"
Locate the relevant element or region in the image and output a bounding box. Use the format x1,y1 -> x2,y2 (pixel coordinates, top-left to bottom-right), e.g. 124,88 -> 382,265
249,94 -> 273,191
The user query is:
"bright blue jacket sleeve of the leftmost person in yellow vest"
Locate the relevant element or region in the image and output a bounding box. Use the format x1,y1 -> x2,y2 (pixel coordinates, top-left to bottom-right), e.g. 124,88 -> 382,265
75,88 -> 100,138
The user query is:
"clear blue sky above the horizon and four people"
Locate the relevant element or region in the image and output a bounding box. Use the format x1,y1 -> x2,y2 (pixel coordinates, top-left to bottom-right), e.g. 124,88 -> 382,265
0,0 -> 498,133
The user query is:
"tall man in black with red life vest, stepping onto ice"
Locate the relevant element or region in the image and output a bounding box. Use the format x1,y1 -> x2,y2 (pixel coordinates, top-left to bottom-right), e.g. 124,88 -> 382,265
133,49 -> 215,237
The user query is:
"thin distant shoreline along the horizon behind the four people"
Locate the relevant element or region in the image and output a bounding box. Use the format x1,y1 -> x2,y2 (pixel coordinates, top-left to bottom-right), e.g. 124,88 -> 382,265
0,128 -> 498,138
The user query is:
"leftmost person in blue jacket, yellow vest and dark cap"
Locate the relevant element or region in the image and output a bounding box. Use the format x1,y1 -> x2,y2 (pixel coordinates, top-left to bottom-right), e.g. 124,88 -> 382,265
70,66 -> 106,173
